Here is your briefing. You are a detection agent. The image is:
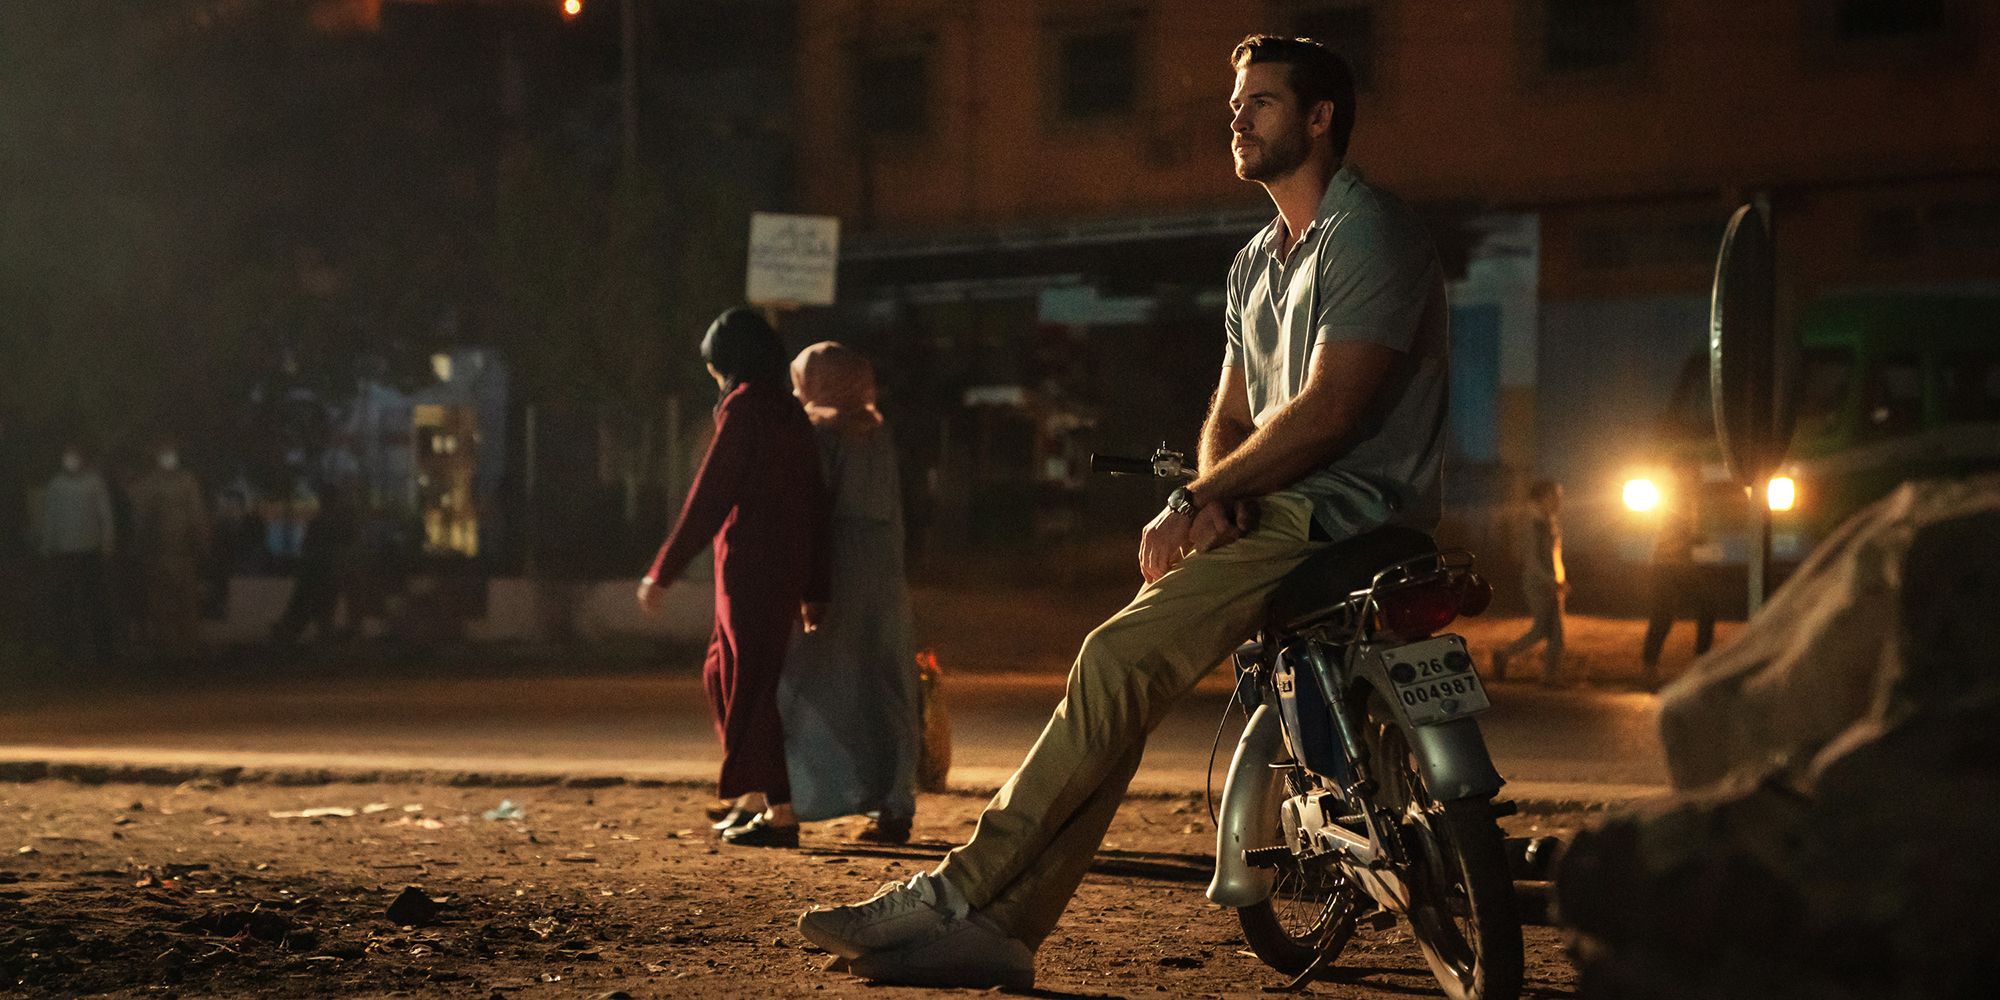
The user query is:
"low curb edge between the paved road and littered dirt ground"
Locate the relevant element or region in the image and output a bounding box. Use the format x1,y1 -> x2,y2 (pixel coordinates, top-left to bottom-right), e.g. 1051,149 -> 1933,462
0,754 -> 1666,816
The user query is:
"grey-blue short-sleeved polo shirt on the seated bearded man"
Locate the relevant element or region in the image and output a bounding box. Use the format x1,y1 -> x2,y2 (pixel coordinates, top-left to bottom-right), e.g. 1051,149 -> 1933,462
1224,168 -> 1450,540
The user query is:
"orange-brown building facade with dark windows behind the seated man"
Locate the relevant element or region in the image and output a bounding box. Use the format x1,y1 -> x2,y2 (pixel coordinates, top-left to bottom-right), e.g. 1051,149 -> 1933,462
794,0 -> 2000,576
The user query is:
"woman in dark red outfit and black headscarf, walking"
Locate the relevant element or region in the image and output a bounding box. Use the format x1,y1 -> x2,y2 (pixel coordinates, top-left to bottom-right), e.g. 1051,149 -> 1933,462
638,308 -> 828,848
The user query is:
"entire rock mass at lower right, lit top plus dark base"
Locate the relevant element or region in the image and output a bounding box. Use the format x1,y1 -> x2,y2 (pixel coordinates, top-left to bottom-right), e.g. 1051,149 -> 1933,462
1556,476 -> 2000,1000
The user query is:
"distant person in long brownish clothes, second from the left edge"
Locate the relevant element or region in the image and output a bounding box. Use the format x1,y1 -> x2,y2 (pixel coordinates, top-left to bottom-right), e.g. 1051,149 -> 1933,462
132,440 -> 210,664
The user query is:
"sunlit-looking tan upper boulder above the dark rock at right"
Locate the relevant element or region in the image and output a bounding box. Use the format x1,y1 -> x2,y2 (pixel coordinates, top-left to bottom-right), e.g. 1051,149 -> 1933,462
1660,476 -> 2000,790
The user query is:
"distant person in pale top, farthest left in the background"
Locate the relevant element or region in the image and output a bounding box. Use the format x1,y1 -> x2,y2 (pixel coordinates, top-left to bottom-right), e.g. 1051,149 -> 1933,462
32,442 -> 118,664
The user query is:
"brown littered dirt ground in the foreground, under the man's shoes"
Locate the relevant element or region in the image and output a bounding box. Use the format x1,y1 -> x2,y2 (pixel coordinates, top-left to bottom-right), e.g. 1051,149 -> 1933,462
0,782 -> 1578,998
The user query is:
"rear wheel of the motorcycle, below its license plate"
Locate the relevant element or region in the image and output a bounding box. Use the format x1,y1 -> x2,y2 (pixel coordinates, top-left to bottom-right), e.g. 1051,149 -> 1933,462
1368,700 -> 1522,1000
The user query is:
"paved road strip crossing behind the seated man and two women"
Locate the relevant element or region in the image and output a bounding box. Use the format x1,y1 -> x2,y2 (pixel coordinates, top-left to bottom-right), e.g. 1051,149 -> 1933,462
0,648 -> 1664,798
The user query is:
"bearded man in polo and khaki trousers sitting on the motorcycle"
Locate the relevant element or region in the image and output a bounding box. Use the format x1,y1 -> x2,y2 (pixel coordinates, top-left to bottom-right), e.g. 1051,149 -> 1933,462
800,36 -> 1448,988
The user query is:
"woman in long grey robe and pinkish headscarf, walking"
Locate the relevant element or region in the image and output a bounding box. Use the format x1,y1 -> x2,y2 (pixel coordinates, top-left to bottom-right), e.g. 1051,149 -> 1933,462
778,340 -> 920,844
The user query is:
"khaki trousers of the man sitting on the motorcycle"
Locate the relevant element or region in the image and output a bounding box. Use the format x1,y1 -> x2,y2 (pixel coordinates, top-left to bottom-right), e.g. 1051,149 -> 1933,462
938,494 -> 1326,948
